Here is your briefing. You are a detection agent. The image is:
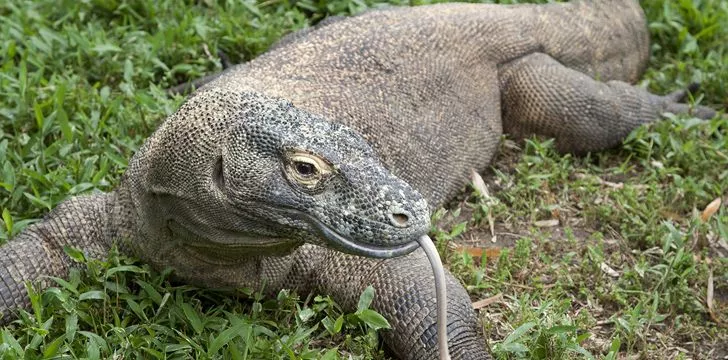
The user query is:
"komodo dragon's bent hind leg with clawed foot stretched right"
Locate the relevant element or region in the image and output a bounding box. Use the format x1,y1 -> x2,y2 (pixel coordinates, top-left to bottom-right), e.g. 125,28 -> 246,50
498,53 -> 715,153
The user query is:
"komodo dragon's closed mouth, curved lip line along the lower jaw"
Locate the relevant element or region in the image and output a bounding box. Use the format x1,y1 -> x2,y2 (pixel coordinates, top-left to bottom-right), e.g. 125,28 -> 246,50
290,210 -> 420,259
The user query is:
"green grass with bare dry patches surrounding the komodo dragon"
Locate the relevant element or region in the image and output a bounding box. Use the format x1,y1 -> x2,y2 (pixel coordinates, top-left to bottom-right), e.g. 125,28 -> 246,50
0,0 -> 728,359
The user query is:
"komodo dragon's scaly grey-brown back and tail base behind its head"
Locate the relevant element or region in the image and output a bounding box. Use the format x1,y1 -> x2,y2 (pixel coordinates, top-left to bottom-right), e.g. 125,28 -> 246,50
210,0 -> 649,207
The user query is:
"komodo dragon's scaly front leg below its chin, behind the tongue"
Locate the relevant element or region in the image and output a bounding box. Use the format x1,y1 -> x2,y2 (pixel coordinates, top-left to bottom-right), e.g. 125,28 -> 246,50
292,245 -> 490,360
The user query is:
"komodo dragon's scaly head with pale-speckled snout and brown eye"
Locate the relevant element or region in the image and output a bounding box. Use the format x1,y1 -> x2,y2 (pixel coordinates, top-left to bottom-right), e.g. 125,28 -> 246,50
124,88 -> 429,257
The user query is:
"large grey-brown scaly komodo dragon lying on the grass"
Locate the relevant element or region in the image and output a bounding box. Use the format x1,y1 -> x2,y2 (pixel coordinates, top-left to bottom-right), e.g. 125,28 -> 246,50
0,0 -> 714,359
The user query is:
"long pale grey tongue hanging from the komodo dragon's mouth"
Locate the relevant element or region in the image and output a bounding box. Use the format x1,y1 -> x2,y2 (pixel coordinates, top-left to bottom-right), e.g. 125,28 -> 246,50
417,235 -> 450,360
